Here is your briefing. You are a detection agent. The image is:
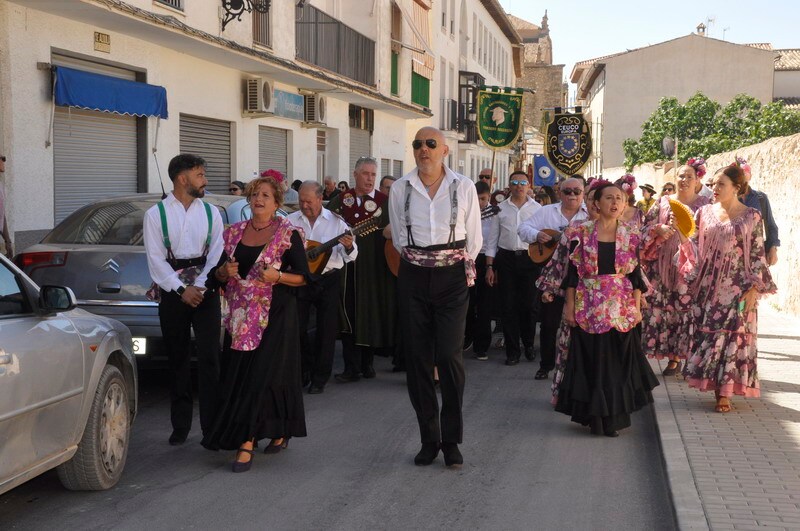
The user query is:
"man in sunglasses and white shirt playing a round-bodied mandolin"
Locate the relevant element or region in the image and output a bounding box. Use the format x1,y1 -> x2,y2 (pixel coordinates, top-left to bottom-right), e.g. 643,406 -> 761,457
517,177 -> 588,380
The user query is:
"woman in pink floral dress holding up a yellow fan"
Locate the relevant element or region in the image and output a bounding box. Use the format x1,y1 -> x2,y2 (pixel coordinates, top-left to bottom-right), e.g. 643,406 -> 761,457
642,165 -> 710,376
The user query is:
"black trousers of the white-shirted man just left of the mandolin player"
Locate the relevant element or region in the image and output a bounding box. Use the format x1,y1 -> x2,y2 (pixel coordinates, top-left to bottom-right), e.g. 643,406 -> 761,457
494,249 -> 541,360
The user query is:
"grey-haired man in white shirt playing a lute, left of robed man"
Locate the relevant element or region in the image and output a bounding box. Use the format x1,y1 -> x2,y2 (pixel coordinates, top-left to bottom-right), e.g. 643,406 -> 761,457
288,181 -> 358,395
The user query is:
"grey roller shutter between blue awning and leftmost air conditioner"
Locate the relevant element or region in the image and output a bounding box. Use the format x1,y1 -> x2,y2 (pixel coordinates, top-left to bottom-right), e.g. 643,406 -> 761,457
180,114 -> 235,194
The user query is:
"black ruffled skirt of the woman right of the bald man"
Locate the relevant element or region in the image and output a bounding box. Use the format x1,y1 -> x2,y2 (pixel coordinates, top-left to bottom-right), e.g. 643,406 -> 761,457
555,327 -> 658,432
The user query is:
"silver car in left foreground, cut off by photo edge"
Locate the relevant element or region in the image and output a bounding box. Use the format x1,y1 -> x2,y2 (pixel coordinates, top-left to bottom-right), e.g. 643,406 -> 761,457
0,256 -> 138,494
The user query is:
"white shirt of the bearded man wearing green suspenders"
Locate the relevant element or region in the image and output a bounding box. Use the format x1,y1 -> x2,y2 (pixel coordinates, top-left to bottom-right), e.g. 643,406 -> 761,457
144,193 -> 223,291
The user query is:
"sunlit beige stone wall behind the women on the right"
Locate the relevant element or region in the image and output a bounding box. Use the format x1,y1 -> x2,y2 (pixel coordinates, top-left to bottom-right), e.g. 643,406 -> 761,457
603,134 -> 800,317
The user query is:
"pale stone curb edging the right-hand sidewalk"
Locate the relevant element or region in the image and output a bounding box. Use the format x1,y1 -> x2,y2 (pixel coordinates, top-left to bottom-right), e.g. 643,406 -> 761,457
649,360 -> 709,530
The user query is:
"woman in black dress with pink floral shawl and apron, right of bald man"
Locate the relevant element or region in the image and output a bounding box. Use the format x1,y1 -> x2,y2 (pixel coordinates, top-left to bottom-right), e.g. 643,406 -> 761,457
555,183 -> 658,437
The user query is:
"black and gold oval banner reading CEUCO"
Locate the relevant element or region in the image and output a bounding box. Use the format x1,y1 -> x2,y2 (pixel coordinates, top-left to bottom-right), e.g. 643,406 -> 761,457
544,108 -> 592,175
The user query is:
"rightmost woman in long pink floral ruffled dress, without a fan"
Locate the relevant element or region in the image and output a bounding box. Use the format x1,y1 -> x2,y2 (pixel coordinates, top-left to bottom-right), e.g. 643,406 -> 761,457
678,164 -> 776,413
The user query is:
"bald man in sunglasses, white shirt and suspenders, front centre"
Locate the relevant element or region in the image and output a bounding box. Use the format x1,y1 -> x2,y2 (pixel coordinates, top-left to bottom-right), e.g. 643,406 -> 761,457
389,127 -> 483,466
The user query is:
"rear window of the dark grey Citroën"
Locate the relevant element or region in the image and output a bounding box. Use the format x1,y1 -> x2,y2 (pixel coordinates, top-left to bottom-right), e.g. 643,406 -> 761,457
42,201 -> 152,245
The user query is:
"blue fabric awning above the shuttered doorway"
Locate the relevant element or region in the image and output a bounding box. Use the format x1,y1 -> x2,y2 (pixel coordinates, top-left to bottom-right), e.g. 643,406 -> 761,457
55,66 -> 168,118
